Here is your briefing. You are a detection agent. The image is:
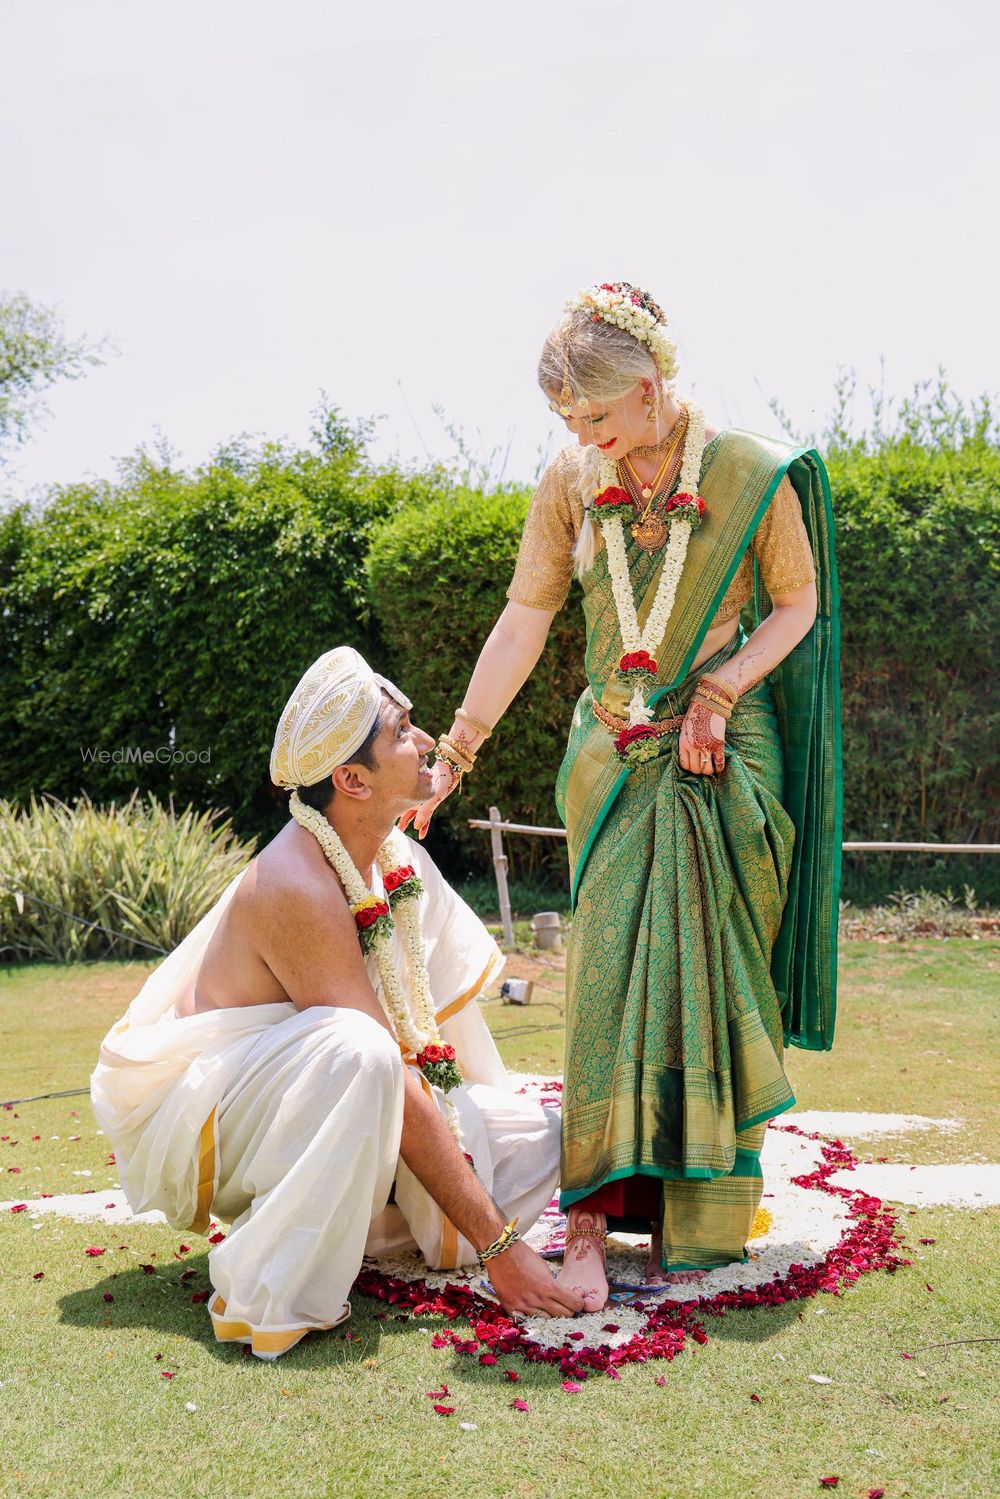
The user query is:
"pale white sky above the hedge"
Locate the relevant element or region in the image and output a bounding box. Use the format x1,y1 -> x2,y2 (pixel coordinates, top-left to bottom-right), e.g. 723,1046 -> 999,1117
0,0 -> 1000,493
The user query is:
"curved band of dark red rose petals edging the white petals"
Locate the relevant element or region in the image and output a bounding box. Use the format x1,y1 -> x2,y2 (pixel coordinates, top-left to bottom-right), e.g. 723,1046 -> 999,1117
354,1124 -> 910,1381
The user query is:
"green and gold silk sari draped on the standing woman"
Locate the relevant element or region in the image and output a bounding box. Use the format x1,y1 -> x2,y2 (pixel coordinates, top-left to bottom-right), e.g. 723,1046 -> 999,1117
556,433 -> 840,1270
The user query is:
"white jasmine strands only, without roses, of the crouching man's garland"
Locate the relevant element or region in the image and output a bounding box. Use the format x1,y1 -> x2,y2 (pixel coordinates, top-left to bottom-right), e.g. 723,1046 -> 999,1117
288,791 -> 462,1147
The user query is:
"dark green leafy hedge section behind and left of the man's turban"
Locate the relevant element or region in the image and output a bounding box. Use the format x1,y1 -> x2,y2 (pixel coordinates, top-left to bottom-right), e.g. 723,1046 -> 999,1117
0,422 -> 439,832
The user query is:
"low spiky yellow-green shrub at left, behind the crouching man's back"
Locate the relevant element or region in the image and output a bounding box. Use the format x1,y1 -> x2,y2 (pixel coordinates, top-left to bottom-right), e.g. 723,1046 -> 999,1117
0,796 -> 253,962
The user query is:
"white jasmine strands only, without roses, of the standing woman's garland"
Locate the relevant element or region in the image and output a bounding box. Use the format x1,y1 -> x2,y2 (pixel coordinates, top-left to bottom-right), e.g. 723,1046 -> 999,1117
597,406 -> 705,726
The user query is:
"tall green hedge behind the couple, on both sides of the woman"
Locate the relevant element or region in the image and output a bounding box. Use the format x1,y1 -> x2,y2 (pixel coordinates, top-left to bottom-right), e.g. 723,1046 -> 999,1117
0,417 -> 1000,893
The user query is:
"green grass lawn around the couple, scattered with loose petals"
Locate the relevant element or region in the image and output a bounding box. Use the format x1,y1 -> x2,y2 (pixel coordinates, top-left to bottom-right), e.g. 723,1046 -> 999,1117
0,940 -> 1000,1499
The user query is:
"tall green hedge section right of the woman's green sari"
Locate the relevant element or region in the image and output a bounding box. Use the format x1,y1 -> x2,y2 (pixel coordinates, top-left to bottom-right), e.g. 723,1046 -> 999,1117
831,441 -> 1000,851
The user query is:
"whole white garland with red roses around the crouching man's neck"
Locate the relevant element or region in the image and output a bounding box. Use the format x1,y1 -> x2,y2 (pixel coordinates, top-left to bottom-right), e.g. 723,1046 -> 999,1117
289,791 -> 462,1121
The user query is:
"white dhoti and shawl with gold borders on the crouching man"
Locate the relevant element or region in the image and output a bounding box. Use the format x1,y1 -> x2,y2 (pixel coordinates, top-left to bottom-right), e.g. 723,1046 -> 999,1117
91,844 -> 559,1358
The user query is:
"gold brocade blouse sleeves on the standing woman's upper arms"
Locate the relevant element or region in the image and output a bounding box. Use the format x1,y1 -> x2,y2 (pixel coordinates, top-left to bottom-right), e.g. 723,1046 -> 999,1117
507,447 -> 816,628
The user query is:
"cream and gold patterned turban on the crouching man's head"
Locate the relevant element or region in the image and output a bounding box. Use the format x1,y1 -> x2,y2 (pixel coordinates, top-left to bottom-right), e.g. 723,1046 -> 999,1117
271,646 -> 412,790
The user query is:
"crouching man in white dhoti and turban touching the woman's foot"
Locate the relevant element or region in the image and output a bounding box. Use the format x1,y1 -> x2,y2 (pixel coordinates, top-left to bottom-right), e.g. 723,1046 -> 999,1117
91,648 -> 582,1358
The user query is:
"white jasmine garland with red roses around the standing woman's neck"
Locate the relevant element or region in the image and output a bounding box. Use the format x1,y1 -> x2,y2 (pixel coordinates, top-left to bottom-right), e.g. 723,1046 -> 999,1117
594,406 -> 705,746
